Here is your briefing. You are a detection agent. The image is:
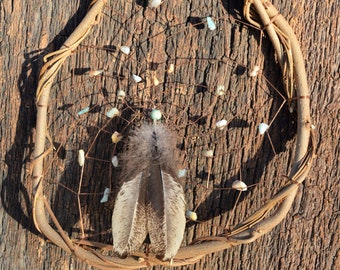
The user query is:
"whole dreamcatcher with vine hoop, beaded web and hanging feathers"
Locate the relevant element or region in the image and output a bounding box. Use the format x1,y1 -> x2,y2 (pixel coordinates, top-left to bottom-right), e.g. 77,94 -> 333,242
32,0 -> 315,269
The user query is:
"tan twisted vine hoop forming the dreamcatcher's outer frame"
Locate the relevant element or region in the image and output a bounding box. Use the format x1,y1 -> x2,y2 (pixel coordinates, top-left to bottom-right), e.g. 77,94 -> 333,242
32,0 -> 315,269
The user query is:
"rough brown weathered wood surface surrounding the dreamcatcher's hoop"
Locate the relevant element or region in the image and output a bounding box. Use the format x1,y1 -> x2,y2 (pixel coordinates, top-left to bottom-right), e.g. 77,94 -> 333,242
0,0 -> 340,269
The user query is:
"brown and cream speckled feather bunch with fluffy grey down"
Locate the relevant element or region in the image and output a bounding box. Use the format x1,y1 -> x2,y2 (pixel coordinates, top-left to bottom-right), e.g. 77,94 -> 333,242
112,124 -> 186,260
